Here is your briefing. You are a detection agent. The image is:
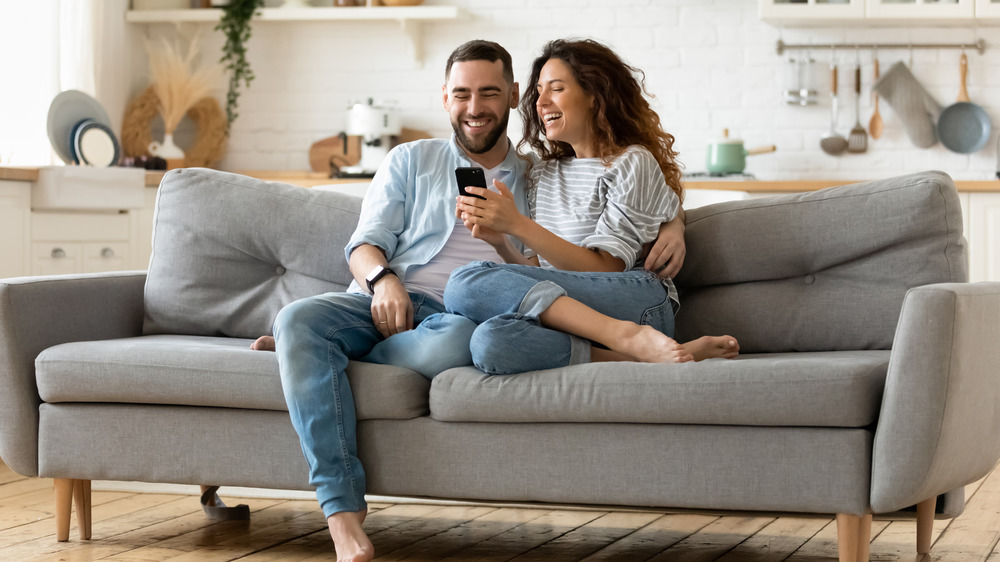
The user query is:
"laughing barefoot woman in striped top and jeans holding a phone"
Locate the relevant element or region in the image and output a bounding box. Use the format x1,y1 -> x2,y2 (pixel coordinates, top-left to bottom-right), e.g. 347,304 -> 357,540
445,40 -> 739,374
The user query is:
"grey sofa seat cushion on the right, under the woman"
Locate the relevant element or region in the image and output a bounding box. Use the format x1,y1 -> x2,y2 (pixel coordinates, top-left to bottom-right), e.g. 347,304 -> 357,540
430,351 -> 889,427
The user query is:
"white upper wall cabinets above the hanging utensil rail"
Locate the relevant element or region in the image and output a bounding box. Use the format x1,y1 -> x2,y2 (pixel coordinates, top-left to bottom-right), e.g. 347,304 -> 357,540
758,0 -> 976,25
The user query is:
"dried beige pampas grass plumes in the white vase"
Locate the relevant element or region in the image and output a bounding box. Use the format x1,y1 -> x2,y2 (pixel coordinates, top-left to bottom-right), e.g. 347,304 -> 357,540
145,35 -> 223,134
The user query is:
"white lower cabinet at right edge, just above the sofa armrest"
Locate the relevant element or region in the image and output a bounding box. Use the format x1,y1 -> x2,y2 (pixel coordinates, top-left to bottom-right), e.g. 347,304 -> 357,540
965,193 -> 1000,281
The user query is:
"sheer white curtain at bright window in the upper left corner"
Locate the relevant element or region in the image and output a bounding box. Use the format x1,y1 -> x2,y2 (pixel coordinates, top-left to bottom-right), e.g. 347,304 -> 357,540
0,0 -> 130,166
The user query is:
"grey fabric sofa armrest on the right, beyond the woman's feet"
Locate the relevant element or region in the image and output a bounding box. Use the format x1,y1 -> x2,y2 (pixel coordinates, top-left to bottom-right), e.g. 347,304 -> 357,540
871,283 -> 1000,513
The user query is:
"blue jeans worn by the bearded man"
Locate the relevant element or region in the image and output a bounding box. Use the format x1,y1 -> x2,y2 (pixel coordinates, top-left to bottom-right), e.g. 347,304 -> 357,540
274,293 -> 475,517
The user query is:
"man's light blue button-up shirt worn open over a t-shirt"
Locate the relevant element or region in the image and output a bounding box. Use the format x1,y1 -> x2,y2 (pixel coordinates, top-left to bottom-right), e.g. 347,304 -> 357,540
345,134 -> 528,292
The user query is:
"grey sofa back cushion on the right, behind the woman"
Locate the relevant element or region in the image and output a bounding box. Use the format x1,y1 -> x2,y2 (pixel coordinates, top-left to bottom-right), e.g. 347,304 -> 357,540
676,172 -> 968,353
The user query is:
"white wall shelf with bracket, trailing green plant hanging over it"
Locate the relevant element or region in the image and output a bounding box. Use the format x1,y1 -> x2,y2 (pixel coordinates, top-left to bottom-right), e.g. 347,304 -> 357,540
125,6 -> 463,66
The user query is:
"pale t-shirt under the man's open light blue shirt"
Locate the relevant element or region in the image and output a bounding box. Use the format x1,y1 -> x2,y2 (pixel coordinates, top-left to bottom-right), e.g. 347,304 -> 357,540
404,167 -> 503,302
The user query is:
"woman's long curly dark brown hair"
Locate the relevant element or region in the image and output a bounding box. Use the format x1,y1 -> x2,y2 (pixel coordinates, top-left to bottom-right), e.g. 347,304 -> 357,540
518,39 -> 683,200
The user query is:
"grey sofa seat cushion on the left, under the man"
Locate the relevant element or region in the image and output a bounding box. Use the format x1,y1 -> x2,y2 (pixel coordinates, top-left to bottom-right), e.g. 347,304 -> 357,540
35,335 -> 430,420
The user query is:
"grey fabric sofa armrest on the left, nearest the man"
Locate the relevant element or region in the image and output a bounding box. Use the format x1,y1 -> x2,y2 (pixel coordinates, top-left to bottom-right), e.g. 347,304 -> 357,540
0,271 -> 146,476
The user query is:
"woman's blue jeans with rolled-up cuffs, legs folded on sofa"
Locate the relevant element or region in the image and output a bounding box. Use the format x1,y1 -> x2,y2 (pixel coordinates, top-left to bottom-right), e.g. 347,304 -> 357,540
444,261 -> 674,375
